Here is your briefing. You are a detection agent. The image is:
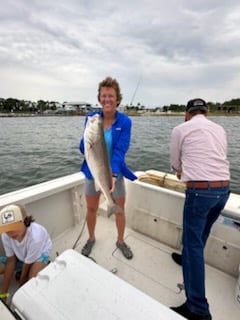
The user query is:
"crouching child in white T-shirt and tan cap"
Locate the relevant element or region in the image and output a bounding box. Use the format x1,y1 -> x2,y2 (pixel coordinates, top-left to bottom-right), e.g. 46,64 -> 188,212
0,204 -> 52,299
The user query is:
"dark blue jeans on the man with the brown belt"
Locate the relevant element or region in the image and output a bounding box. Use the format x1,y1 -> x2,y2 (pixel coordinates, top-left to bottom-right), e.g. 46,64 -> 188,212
182,187 -> 230,315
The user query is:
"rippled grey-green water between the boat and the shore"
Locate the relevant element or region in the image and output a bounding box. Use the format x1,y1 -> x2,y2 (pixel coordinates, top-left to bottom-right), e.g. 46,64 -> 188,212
0,116 -> 240,194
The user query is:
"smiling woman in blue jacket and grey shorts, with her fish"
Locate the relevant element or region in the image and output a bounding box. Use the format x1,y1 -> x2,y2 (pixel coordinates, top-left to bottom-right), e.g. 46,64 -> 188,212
80,77 -> 137,259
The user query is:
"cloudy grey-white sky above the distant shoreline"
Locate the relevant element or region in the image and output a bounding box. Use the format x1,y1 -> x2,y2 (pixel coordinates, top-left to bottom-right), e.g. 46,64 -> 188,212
0,0 -> 240,107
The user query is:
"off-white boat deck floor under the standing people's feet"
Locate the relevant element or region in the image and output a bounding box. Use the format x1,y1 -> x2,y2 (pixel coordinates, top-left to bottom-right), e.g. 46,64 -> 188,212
50,212 -> 240,320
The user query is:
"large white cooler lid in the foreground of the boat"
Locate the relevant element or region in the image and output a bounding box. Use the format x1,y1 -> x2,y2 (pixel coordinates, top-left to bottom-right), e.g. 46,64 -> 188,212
12,249 -> 183,320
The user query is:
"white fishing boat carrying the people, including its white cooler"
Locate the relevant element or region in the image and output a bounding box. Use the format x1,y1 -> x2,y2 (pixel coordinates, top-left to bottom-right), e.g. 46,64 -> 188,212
0,170 -> 240,320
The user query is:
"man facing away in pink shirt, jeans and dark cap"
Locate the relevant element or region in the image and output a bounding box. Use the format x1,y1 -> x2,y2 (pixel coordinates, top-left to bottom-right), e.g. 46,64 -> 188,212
170,99 -> 230,320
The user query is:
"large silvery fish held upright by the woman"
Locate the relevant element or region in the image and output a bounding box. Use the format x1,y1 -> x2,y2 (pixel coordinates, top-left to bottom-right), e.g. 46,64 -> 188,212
83,114 -> 123,217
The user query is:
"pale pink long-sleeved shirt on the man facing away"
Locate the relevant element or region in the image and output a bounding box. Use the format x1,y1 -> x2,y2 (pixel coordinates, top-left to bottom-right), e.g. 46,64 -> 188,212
170,114 -> 230,182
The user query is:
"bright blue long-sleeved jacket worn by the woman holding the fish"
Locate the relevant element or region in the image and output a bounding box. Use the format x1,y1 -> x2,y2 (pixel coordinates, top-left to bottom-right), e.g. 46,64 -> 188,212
79,111 -> 137,180
